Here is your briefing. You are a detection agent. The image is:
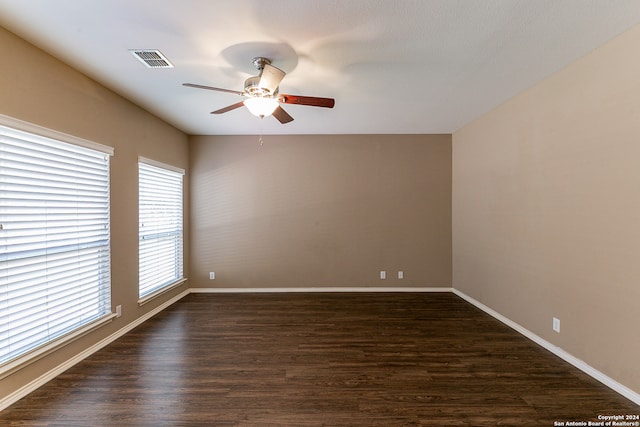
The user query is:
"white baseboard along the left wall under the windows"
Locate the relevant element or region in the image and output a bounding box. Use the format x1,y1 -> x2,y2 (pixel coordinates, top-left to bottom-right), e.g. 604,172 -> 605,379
0,290 -> 189,411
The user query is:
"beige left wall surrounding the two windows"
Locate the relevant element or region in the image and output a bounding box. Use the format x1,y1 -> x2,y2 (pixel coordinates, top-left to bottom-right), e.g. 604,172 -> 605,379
0,28 -> 188,401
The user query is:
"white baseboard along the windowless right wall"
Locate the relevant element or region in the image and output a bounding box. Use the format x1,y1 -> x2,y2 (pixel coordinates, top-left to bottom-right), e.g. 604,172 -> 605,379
452,288 -> 640,405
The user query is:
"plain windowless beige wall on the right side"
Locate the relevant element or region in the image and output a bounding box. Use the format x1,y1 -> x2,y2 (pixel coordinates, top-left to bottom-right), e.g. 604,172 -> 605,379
453,27 -> 640,392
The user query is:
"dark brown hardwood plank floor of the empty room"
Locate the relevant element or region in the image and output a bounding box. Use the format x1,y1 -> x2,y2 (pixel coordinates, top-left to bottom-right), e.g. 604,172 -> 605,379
0,293 -> 640,427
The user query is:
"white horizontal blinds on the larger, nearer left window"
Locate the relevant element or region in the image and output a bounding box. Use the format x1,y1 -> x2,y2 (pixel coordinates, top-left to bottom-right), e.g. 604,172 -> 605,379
0,121 -> 112,366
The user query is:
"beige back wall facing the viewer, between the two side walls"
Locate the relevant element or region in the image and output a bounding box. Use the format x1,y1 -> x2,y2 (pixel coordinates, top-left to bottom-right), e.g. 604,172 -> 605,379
190,135 -> 451,288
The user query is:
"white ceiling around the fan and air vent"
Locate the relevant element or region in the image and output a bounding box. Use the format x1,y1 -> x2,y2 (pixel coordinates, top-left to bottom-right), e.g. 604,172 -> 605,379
0,0 -> 640,135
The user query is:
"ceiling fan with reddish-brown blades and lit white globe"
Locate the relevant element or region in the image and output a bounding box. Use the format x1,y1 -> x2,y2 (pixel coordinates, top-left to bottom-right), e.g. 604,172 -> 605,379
183,57 -> 335,124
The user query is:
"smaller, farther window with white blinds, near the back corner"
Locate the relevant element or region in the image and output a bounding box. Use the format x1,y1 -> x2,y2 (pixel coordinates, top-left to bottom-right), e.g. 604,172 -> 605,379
138,158 -> 184,302
